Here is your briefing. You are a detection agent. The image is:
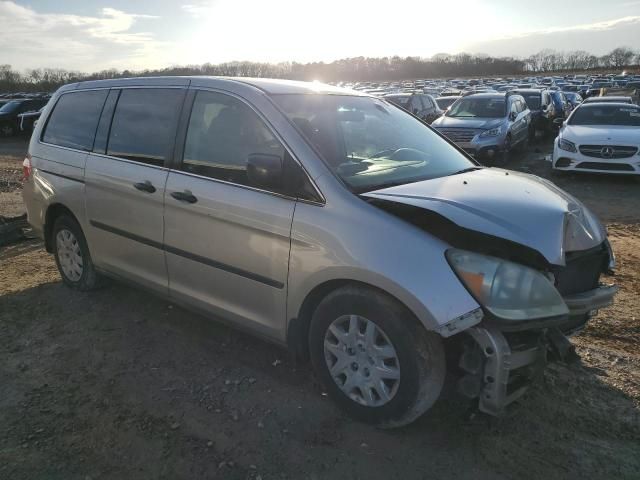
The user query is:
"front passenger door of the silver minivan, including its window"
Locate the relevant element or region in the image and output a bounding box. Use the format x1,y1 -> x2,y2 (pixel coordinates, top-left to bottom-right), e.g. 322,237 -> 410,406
165,90 -> 296,338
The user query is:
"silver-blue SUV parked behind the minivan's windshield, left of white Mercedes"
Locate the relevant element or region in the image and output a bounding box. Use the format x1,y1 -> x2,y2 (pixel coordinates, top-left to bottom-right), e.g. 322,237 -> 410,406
431,92 -> 534,165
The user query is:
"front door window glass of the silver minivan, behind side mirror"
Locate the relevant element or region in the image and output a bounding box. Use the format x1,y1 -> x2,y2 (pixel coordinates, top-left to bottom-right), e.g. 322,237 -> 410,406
182,91 -> 285,186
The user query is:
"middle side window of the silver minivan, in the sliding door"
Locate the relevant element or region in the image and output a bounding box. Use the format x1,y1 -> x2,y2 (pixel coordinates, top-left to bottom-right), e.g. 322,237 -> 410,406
107,88 -> 184,165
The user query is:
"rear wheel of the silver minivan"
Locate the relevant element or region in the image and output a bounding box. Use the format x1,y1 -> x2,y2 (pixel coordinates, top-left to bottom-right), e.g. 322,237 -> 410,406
52,215 -> 100,291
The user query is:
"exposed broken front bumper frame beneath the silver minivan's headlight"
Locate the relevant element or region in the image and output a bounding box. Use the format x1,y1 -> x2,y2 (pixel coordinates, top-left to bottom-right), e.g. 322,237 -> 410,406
458,285 -> 618,415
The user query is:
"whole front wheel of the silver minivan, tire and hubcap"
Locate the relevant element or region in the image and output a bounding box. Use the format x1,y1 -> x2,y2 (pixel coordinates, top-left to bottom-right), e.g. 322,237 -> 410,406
309,286 -> 445,428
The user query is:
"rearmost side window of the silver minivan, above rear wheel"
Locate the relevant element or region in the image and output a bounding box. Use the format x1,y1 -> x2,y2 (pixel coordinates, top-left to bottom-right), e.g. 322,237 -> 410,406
42,90 -> 109,151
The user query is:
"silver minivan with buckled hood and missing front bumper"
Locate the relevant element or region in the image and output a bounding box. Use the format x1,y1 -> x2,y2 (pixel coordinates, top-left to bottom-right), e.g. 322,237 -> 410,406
24,77 -> 616,427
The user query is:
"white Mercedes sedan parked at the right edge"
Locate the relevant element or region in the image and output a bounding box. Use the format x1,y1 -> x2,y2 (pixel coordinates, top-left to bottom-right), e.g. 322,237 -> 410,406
551,103 -> 640,175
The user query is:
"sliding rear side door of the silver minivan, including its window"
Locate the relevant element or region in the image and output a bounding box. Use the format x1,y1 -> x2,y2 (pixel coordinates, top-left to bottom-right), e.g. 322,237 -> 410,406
85,88 -> 186,293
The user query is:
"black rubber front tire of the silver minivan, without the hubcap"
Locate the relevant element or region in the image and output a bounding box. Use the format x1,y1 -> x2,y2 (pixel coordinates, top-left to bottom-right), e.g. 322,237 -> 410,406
309,285 -> 446,428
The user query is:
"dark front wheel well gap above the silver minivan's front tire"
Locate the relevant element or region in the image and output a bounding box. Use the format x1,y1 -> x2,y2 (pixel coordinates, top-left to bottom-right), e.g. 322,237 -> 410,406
287,279 -> 420,361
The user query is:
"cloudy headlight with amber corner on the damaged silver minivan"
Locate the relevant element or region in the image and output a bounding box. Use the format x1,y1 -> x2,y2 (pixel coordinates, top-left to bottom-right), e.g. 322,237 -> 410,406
447,249 -> 569,321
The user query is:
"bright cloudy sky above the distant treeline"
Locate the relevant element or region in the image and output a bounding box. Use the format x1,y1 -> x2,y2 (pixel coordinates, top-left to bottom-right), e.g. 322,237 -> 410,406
0,0 -> 640,72
